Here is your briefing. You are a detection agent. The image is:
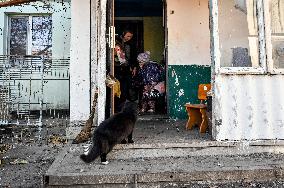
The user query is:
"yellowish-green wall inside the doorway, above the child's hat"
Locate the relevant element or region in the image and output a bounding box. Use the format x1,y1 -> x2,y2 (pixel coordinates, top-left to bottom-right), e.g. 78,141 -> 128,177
143,17 -> 164,62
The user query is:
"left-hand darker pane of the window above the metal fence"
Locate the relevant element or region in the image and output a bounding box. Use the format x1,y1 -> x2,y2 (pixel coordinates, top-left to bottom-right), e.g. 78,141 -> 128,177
10,17 -> 28,55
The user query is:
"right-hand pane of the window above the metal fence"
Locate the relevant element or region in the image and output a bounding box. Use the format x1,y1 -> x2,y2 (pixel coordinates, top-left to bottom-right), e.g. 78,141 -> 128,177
32,16 -> 52,56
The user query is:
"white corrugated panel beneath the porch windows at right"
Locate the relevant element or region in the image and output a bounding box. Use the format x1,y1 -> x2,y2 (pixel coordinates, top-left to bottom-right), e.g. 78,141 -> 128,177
213,75 -> 284,140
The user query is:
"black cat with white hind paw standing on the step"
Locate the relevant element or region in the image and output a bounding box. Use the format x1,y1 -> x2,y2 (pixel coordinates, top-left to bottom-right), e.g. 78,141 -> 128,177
80,101 -> 137,164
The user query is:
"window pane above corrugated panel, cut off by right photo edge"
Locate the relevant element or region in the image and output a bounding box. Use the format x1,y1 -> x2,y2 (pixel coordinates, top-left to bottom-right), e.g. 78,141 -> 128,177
269,0 -> 284,68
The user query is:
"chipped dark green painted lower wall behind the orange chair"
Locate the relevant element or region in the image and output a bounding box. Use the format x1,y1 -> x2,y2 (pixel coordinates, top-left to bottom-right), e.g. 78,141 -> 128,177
167,65 -> 211,119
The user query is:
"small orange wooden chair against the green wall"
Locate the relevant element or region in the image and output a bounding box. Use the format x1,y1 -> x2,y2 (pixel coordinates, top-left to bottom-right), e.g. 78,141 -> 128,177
185,84 -> 211,133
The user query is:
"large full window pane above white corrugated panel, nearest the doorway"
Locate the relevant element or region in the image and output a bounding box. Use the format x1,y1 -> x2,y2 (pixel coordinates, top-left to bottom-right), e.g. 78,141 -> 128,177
218,0 -> 259,68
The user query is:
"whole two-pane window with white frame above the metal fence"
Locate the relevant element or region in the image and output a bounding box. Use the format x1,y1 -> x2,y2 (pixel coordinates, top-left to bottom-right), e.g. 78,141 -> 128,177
8,15 -> 52,56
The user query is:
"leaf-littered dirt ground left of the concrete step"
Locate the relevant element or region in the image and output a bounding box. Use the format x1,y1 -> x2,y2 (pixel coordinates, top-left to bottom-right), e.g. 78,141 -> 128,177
0,118 -> 67,187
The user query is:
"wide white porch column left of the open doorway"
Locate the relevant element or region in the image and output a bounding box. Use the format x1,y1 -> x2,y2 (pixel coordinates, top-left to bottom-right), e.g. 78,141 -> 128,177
67,0 -> 91,137
